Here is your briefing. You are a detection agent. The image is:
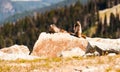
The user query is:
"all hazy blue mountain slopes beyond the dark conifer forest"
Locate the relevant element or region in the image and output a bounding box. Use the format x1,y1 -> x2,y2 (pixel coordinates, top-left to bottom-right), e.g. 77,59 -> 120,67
0,0 -> 88,24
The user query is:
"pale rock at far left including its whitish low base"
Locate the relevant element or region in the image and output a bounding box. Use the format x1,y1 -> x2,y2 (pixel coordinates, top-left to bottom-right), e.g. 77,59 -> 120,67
0,45 -> 38,60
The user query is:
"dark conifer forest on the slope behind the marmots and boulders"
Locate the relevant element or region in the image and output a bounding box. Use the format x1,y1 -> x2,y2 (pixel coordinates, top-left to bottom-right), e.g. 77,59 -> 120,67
0,0 -> 120,51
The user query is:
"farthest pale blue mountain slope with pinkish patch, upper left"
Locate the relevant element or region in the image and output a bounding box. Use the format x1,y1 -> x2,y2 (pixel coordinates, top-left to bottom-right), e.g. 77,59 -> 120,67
0,0 -> 62,22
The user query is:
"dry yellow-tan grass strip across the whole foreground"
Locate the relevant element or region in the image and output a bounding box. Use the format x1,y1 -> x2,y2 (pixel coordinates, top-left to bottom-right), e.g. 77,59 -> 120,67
0,55 -> 120,72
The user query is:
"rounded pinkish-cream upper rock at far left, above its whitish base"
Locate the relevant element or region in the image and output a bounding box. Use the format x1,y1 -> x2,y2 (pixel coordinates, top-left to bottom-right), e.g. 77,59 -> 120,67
0,45 -> 30,55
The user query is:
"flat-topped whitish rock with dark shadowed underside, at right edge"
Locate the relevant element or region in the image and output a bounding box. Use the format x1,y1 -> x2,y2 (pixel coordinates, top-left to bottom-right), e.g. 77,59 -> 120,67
86,38 -> 120,55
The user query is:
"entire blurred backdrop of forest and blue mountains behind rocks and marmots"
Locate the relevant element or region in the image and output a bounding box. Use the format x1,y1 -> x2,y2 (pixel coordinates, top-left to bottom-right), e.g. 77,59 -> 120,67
0,0 -> 120,50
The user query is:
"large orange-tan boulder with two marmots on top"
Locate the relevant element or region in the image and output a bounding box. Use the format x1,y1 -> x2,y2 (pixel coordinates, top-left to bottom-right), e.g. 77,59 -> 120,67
31,32 -> 88,57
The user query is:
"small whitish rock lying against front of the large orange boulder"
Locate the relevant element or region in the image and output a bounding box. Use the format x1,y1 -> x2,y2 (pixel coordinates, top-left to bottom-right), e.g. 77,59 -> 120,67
58,47 -> 85,57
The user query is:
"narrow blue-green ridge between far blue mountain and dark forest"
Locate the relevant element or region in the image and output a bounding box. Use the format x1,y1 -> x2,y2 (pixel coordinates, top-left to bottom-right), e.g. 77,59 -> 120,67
2,0 -> 77,22
